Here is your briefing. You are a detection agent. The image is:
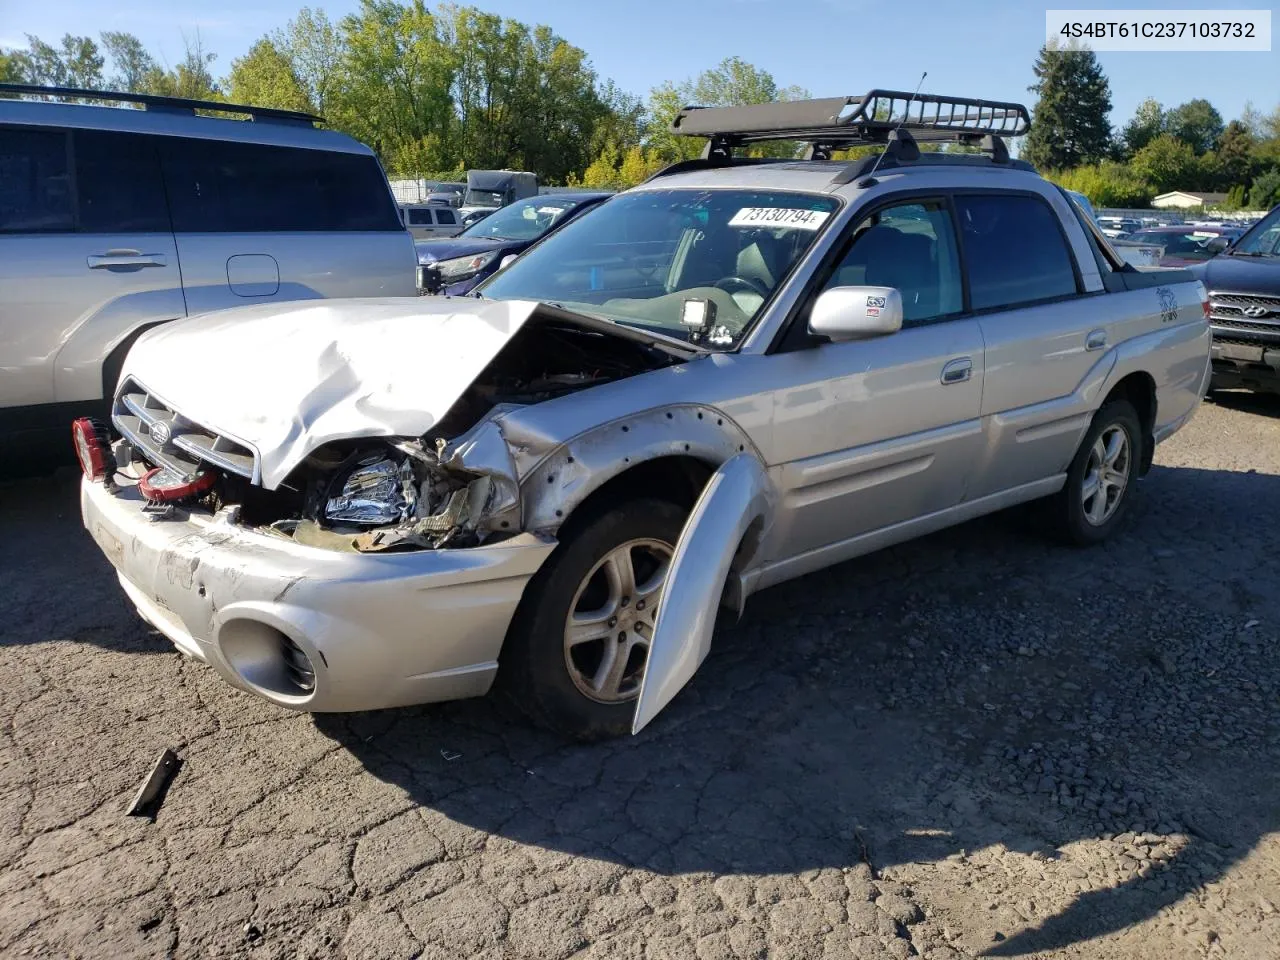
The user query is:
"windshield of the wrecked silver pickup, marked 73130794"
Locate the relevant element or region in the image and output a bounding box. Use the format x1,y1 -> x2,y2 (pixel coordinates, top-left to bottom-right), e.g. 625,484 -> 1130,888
481,189 -> 837,348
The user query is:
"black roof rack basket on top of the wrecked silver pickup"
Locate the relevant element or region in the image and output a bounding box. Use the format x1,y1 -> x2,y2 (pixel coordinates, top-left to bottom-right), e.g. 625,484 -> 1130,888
671,90 -> 1032,159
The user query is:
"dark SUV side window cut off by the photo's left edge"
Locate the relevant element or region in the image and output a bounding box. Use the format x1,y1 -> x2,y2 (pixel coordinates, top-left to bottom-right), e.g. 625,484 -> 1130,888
0,128 -> 76,233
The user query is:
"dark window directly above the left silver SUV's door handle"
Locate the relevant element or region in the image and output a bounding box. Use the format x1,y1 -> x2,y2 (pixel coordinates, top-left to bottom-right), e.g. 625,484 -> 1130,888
73,131 -> 169,233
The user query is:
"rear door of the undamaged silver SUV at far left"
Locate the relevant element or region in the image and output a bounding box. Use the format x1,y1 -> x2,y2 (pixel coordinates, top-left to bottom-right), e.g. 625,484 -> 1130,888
0,127 -> 186,407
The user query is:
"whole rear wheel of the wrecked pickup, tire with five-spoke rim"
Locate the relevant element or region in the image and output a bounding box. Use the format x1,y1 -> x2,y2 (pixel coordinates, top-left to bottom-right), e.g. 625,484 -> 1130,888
1046,399 -> 1144,547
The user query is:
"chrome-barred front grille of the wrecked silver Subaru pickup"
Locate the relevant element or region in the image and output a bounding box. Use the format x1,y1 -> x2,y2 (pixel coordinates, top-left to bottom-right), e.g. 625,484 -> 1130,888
111,378 -> 255,480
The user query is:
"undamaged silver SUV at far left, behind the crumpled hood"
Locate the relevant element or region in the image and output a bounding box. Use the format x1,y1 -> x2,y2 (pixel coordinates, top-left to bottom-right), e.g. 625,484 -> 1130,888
0,84 -> 417,460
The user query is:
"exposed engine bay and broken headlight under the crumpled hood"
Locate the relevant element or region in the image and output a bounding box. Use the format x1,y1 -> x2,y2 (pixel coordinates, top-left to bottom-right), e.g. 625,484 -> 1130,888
174,317 -> 681,553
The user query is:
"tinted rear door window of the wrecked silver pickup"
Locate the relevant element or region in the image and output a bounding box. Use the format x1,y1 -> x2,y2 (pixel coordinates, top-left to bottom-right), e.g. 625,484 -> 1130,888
956,193 -> 1078,310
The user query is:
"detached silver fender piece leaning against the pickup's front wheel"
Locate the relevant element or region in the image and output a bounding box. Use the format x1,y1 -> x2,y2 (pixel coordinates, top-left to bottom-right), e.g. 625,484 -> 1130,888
631,452 -> 773,733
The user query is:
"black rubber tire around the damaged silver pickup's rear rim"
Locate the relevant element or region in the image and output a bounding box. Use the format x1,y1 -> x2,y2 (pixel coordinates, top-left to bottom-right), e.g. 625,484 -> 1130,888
1046,399 -> 1146,547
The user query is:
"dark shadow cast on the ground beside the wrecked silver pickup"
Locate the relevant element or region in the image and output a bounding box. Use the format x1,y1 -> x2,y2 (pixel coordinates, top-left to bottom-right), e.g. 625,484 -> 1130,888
315,467 -> 1280,956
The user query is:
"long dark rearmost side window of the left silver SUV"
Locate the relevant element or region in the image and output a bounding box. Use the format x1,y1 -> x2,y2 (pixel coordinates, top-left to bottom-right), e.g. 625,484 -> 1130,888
161,138 -> 404,233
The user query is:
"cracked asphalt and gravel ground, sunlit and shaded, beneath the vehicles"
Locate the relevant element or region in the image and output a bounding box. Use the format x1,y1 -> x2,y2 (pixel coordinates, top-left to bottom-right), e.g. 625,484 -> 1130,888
0,397 -> 1280,960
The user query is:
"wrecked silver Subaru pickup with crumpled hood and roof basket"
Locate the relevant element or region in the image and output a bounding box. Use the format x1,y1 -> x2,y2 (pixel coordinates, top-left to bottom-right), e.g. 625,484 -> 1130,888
77,91 -> 1210,737
